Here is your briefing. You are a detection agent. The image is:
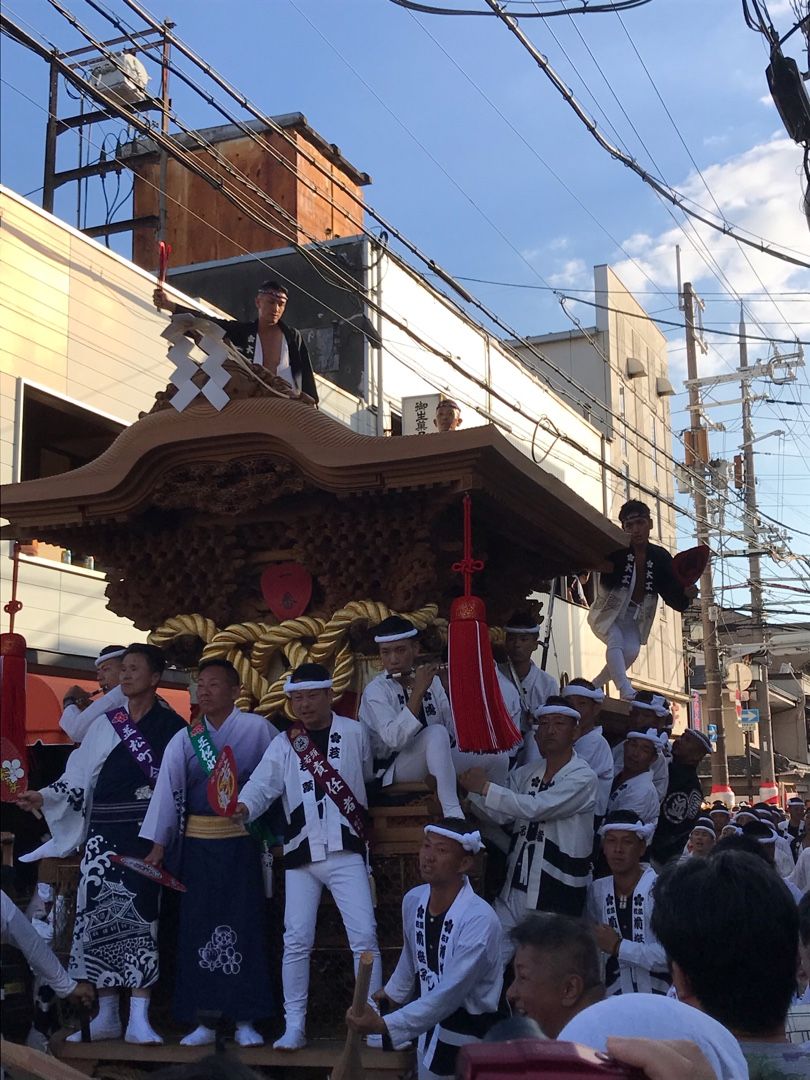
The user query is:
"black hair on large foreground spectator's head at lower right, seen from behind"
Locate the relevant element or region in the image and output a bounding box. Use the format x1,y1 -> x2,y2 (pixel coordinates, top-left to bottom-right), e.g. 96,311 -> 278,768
651,845 -> 799,1038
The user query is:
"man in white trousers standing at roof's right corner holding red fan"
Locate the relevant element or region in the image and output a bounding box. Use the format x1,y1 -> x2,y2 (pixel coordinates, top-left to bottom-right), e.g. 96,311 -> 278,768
588,499 -> 698,700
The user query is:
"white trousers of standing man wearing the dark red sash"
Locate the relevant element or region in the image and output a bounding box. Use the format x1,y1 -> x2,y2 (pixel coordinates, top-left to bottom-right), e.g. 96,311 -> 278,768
281,851 -> 382,1030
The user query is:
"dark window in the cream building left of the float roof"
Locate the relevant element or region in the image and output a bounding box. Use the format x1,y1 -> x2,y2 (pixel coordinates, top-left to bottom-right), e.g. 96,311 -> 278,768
19,384 -> 124,480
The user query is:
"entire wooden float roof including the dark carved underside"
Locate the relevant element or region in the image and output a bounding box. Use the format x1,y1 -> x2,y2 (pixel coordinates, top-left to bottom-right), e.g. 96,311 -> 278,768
2,397 -> 622,629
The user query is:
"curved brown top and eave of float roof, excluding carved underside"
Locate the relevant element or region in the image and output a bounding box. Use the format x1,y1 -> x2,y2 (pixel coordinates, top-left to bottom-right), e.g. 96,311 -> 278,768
2,397 -> 621,569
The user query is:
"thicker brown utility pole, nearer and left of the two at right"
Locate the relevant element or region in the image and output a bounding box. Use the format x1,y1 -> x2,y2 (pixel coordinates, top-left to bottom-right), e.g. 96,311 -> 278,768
684,281 -> 732,798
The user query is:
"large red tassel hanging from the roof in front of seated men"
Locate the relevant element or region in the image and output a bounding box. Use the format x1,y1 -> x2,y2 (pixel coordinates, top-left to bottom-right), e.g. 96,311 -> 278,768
447,495 -> 521,753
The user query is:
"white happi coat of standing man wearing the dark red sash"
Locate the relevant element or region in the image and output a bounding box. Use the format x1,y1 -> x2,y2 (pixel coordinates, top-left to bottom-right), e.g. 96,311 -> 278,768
239,713 -> 372,862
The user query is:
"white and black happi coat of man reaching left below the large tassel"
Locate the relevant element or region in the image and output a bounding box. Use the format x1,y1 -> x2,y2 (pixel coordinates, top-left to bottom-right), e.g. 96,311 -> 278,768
471,751 -> 597,914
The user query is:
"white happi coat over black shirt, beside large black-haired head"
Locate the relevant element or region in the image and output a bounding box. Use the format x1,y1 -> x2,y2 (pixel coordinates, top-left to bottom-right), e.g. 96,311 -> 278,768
585,868 -> 672,997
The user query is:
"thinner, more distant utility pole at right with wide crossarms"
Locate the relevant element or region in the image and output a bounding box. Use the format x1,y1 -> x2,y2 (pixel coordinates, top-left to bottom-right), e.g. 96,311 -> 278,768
740,311 -> 777,787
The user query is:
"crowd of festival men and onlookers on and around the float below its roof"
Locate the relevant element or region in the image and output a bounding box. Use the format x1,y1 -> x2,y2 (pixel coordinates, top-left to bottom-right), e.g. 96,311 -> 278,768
3,492 -> 810,1080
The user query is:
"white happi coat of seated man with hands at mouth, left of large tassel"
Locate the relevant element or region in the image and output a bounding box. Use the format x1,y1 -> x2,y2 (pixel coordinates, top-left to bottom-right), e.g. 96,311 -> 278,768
357,672 -> 456,784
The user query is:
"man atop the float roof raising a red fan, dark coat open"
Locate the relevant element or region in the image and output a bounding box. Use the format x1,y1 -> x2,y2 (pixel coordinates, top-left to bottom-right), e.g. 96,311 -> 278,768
152,281 -> 318,405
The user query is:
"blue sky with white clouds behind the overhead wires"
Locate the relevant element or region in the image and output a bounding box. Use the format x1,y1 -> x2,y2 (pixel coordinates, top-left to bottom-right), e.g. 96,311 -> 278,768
0,0 -> 810,611
